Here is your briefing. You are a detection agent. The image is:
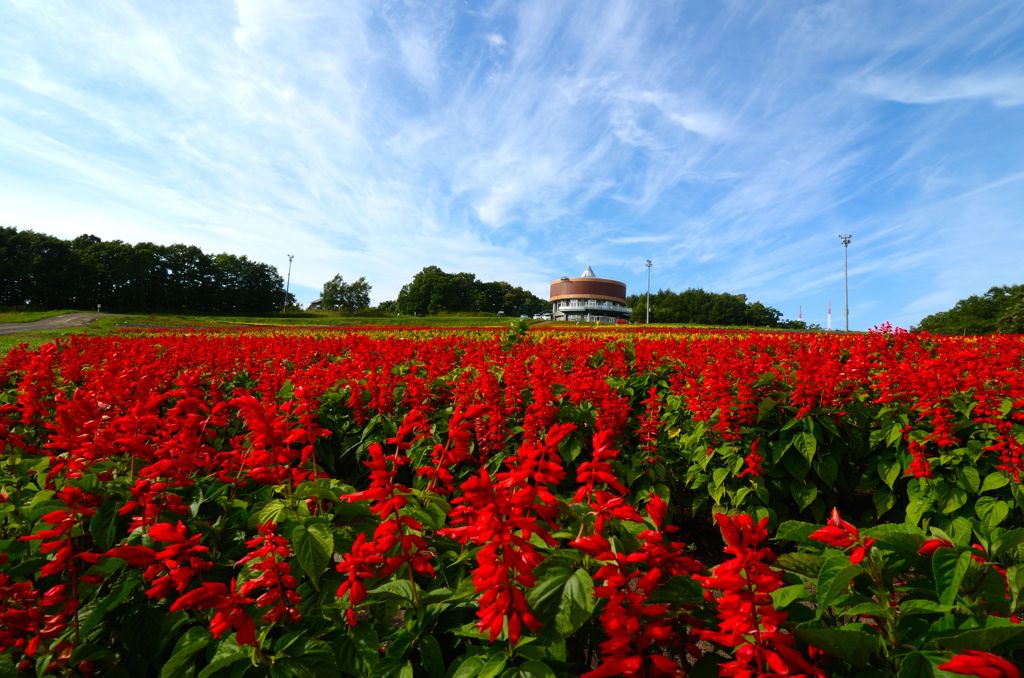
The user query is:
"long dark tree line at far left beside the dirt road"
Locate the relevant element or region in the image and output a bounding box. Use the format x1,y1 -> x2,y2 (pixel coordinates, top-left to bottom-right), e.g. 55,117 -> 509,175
0,226 -> 294,313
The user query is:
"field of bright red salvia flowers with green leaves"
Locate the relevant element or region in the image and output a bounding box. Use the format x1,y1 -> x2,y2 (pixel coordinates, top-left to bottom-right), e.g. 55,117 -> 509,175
0,329 -> 1024,678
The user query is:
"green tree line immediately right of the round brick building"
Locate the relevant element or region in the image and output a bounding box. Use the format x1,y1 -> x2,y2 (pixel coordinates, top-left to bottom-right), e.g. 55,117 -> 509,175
626,289 -> 790,329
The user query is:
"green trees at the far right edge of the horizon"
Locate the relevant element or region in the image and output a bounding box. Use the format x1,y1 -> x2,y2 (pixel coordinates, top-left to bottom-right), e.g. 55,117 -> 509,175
914,285 -> 1024,334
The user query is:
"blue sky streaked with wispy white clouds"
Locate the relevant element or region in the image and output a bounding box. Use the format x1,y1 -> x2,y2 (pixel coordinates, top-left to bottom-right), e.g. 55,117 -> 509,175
0,0 -> 1024,329
